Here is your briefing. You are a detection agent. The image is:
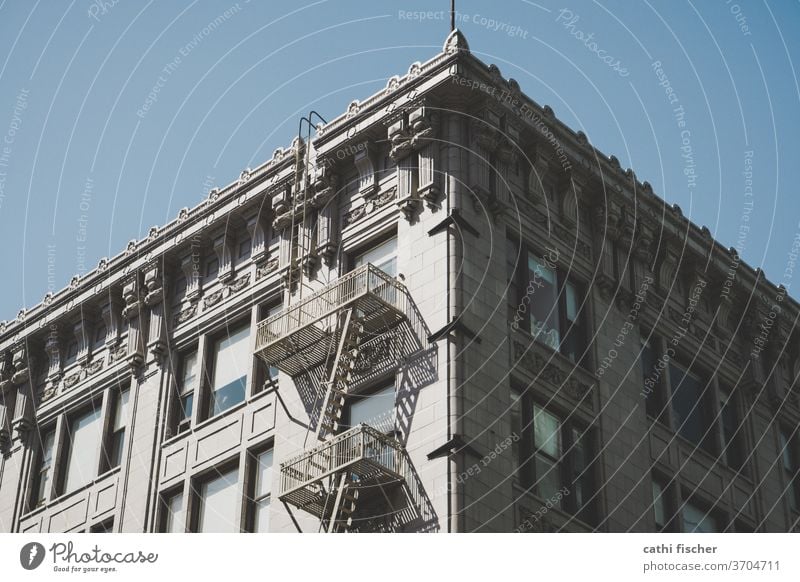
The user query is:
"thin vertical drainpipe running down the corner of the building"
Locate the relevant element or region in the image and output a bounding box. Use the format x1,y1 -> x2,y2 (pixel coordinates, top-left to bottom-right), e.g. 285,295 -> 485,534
446,112 -> 466,533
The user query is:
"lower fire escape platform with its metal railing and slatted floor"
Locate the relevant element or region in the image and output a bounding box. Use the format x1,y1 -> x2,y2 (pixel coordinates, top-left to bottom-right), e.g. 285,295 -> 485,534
278,424 -> 407,519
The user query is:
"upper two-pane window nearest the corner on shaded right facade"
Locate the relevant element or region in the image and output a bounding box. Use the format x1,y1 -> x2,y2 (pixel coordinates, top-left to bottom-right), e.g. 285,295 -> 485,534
507,242 -> 586,363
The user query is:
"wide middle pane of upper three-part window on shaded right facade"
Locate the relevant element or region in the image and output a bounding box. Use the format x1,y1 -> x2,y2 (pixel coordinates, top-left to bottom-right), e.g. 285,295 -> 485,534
669,363 -> 713,452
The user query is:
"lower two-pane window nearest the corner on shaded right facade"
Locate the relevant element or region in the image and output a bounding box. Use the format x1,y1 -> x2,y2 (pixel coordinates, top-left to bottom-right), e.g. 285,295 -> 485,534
511,392 -> 593,523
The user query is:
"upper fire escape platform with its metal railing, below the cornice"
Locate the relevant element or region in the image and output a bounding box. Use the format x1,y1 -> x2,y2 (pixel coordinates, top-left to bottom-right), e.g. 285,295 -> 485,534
255,264 -> 410,377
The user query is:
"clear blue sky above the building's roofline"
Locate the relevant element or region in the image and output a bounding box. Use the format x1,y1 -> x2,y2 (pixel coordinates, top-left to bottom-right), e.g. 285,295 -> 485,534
0,0 -> 800,320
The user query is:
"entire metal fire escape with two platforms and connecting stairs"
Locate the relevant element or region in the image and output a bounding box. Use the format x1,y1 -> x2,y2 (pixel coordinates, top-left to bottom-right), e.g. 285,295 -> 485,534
256,264 -> 432,532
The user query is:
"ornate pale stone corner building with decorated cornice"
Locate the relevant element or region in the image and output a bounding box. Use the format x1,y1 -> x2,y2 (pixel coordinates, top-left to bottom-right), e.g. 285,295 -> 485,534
0,31 -> 800,532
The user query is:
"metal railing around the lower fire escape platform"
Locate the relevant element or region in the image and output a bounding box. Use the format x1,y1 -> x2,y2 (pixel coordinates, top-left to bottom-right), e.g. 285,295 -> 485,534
279,424 -> 406,497
